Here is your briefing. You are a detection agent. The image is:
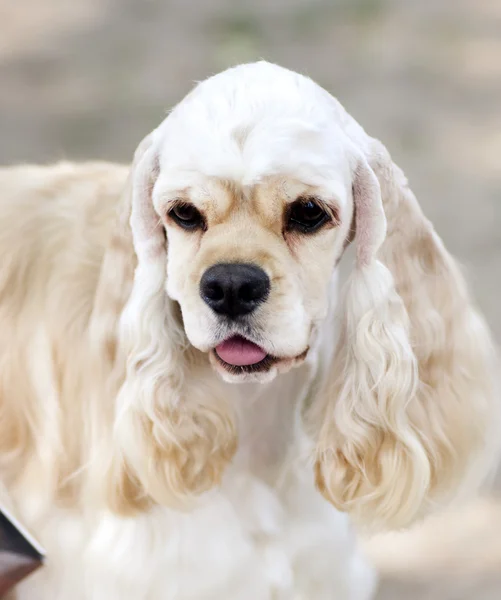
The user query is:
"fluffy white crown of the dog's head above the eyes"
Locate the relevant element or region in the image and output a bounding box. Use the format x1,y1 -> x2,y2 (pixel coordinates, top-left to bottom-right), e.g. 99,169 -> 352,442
157,63 -> 350,193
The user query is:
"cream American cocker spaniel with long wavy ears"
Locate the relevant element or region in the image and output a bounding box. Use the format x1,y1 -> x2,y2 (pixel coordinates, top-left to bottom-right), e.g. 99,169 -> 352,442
0,62 -> 499,600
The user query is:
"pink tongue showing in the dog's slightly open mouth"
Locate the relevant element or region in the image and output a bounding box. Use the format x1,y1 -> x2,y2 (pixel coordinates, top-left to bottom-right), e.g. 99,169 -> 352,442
214,335 -> 278,374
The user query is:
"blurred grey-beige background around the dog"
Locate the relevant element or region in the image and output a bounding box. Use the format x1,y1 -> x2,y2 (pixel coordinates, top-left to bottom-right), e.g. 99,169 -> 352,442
0,0 -> 501,600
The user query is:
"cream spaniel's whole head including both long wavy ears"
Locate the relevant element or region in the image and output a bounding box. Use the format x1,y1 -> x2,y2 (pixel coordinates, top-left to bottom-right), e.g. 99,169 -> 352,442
105,63 -> 492,523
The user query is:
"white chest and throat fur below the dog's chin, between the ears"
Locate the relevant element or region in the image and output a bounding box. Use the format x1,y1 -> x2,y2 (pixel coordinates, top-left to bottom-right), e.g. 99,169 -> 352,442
13,365 -> 373,600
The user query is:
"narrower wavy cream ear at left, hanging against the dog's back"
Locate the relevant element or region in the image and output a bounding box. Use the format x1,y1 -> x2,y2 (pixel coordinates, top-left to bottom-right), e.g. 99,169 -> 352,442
99,132 -> 236,510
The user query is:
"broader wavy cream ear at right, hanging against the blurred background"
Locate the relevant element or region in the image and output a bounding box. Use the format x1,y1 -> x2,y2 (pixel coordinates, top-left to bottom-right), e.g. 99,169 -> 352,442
313,140 -> 499,527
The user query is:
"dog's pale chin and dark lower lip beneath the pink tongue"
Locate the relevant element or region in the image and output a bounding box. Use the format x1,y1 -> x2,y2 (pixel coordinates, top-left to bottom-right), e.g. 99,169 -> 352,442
209,349 -> 308,383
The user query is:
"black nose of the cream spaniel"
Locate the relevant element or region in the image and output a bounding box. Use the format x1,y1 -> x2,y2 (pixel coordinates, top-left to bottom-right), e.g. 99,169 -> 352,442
200,263 -> 270,319
